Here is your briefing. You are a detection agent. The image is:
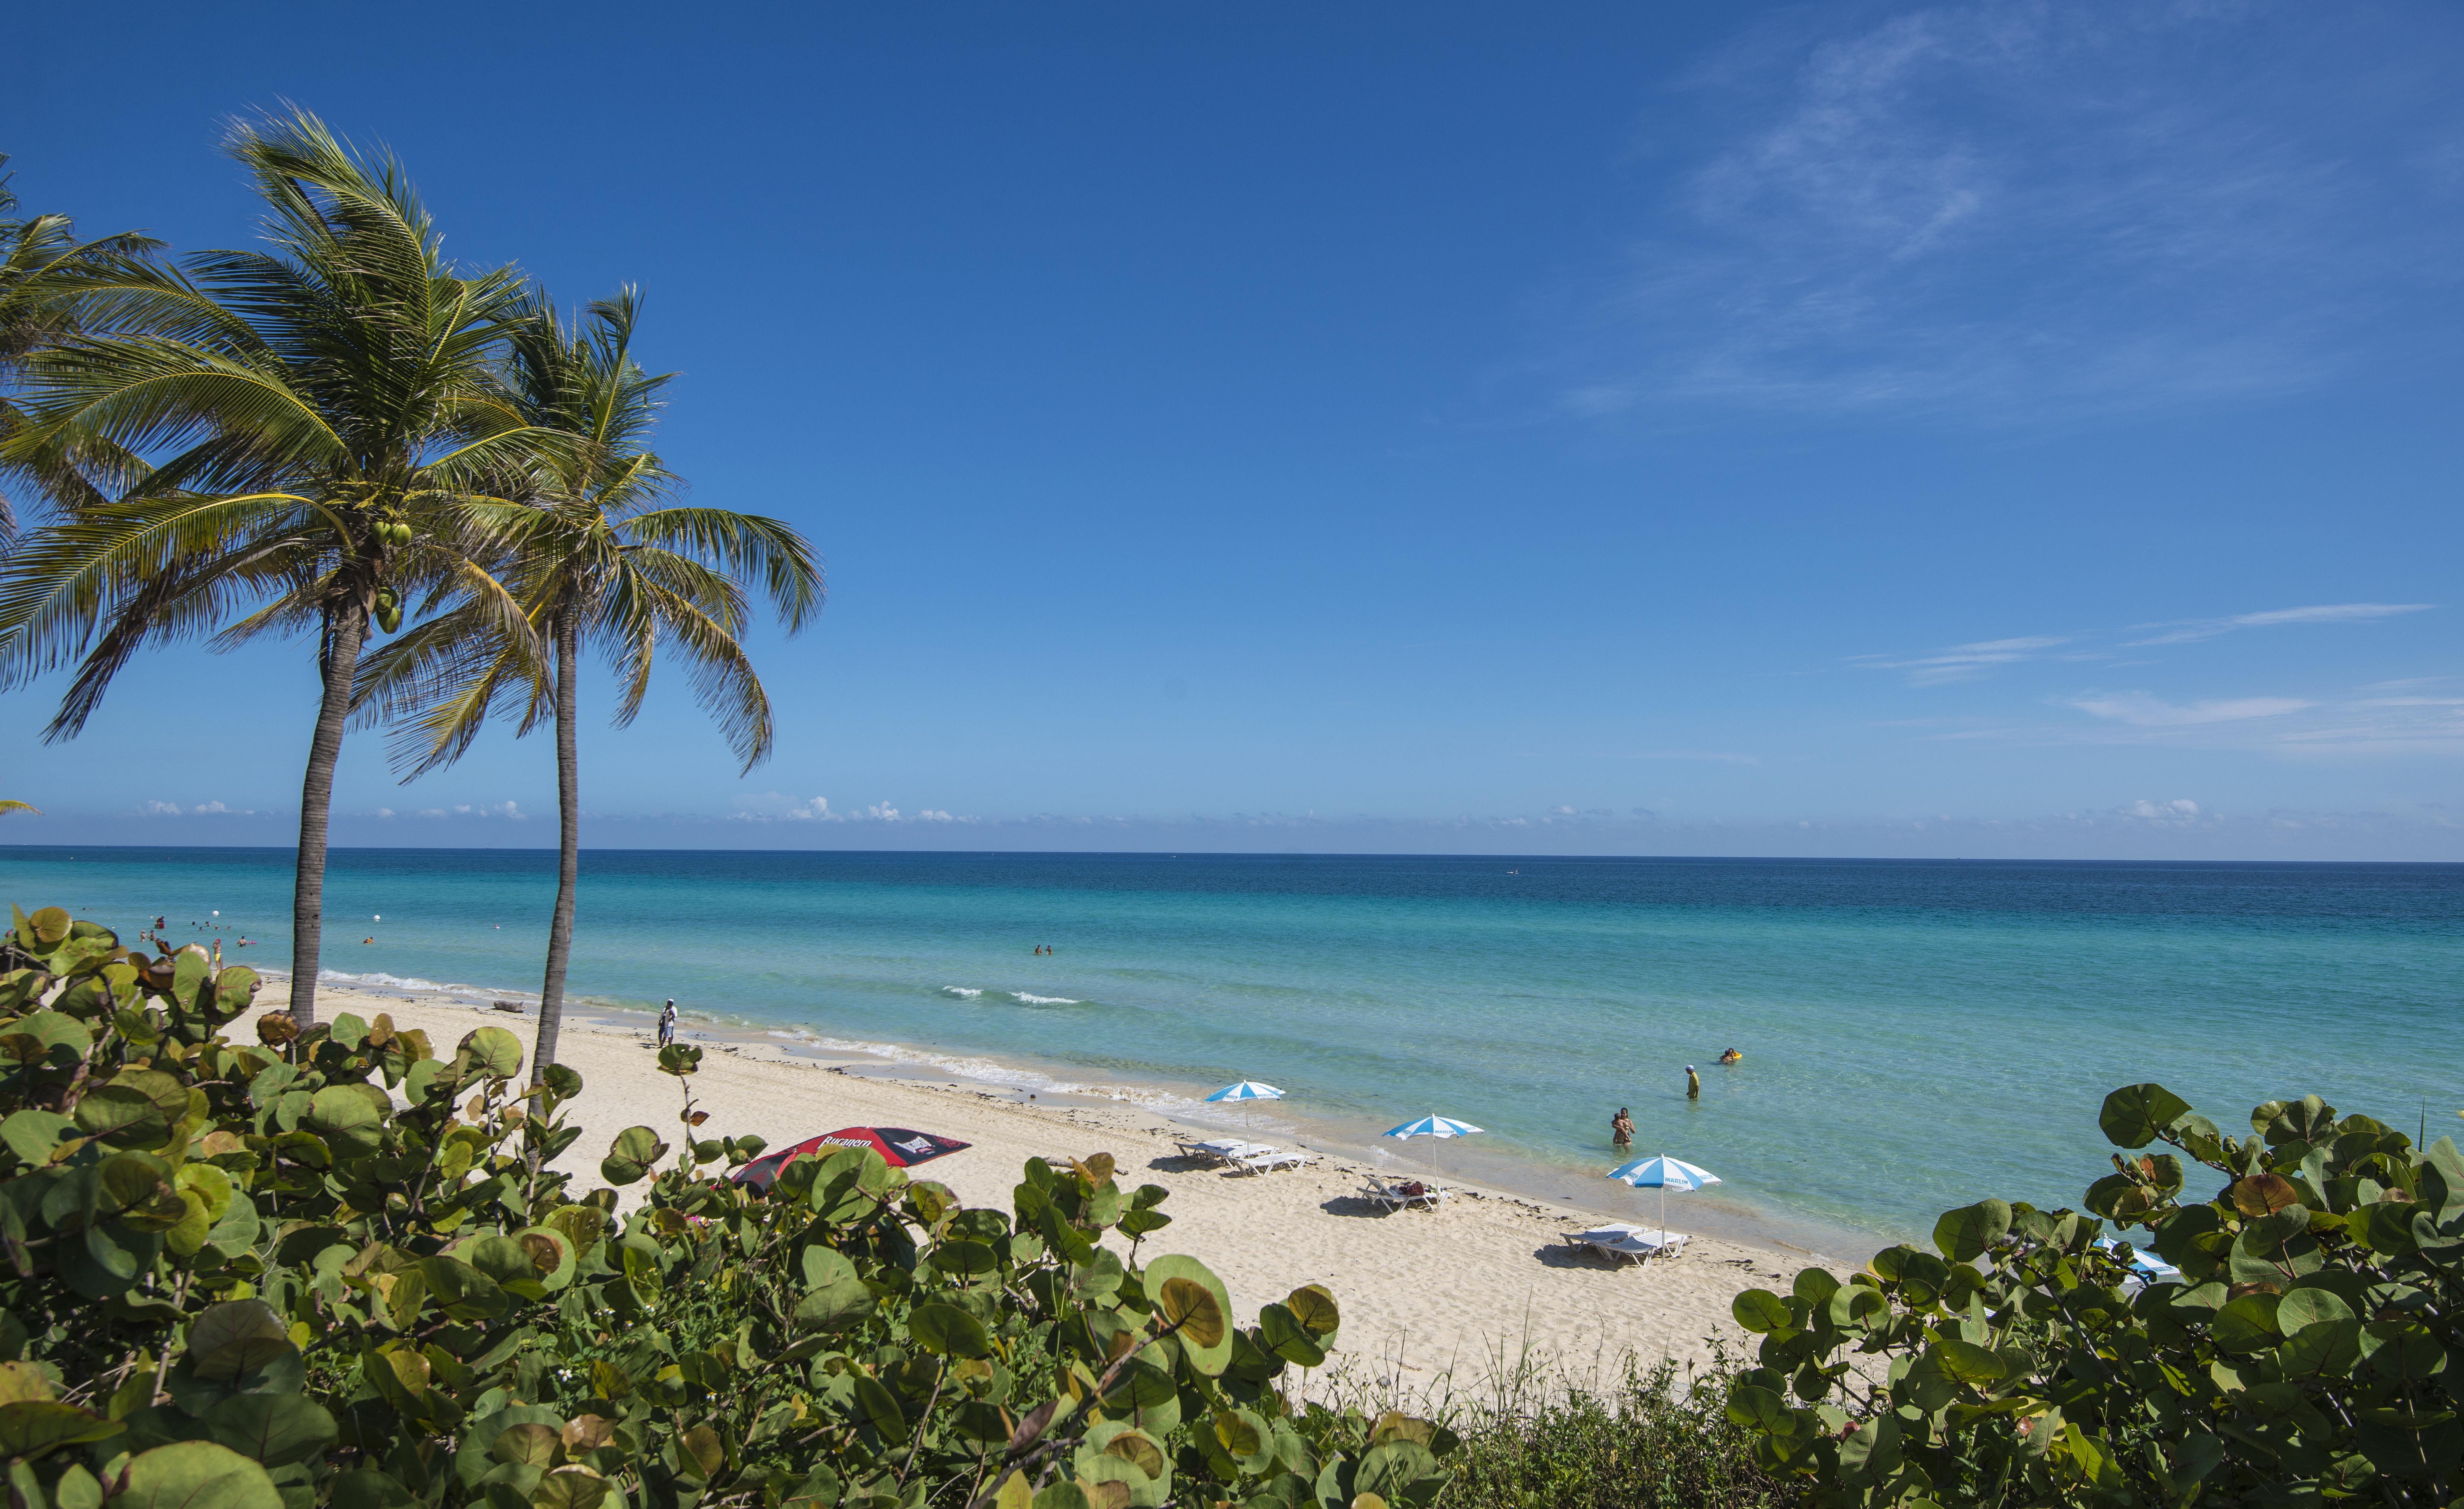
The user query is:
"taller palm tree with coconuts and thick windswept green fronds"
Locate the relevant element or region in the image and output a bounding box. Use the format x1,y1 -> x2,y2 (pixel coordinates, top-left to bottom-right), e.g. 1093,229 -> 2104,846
0,113 -> 557,1023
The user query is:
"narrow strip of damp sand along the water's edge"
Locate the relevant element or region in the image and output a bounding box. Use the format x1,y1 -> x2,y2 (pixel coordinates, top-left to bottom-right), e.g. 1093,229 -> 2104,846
280,959 -> 1872,1270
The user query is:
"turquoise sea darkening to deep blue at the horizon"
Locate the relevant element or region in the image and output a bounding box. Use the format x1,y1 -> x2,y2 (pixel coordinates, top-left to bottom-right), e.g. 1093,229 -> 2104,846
0,848 -> 2464,1250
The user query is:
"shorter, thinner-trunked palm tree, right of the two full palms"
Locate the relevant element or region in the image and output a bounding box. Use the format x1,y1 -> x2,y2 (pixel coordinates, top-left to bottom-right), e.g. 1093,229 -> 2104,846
360,288 -> 823,1075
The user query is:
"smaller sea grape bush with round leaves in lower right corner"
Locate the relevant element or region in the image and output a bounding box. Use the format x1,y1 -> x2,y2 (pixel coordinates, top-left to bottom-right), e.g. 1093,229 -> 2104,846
1730,1085 -> 2464,1509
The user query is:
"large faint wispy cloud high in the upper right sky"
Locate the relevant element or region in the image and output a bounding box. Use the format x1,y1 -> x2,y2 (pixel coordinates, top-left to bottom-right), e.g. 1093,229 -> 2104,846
1562,2 -> 2464,422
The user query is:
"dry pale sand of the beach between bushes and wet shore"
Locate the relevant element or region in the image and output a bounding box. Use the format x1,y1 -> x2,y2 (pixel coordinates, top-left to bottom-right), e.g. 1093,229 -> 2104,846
255,981 -> 1806,1393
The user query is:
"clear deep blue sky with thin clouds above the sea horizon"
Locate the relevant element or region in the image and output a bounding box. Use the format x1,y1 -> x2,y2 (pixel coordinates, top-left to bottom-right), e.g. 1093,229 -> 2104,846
0,2 -> 2464,860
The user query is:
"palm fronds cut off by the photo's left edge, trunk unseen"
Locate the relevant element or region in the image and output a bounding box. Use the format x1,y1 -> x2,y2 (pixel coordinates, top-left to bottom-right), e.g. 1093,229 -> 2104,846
0,153 -> 160,540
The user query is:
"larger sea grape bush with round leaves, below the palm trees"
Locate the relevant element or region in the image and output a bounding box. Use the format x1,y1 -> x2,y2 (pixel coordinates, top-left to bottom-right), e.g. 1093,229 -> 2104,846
0,907 -> 1456,1509
